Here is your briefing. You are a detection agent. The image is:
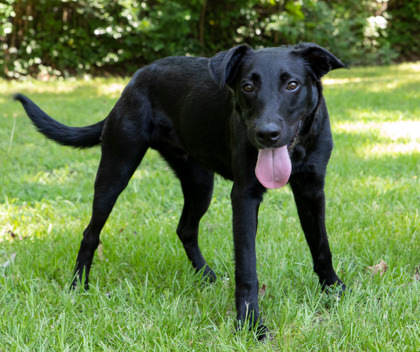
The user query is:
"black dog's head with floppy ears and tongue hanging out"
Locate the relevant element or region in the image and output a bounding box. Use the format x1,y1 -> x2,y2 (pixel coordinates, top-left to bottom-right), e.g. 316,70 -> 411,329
209,43 -> 345,188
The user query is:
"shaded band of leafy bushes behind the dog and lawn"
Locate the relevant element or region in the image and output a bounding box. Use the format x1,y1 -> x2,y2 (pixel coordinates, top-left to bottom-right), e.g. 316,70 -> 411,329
0,0 -> 420,79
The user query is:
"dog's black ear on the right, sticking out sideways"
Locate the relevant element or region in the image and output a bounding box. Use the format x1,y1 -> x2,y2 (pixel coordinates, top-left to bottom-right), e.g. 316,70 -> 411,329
291,43 -> 347,80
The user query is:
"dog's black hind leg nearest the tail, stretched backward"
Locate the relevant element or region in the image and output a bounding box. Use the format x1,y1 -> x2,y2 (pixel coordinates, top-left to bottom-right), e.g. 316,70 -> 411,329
72,115 -> 149,289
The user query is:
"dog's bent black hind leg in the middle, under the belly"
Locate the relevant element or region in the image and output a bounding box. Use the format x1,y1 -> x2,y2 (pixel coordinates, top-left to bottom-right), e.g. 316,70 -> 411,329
159,150 -> 216,282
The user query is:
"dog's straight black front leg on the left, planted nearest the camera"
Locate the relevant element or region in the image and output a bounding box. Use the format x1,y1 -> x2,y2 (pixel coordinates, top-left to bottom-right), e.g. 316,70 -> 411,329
231,184 -> 267,339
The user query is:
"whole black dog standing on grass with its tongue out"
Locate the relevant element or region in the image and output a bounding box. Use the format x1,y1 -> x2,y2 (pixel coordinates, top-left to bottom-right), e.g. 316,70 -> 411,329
15,43 -> 345,338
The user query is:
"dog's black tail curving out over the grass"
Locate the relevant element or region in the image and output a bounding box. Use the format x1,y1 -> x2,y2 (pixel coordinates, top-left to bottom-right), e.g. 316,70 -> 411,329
13,94 -> 106,148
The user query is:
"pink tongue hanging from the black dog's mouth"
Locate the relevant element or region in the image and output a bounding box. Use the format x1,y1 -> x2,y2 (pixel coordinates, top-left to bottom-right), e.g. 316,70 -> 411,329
255,145 -> 292,188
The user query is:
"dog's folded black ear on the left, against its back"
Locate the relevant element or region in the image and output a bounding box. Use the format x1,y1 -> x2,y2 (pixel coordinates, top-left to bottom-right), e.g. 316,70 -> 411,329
209,45 -> 252,88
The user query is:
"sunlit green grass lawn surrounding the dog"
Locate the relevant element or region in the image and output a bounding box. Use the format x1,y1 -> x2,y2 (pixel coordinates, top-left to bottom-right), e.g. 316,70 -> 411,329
0,64 -> 420,352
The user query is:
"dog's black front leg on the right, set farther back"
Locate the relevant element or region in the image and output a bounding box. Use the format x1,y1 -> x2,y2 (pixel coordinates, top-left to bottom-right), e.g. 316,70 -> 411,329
290,173 -> 346,291
